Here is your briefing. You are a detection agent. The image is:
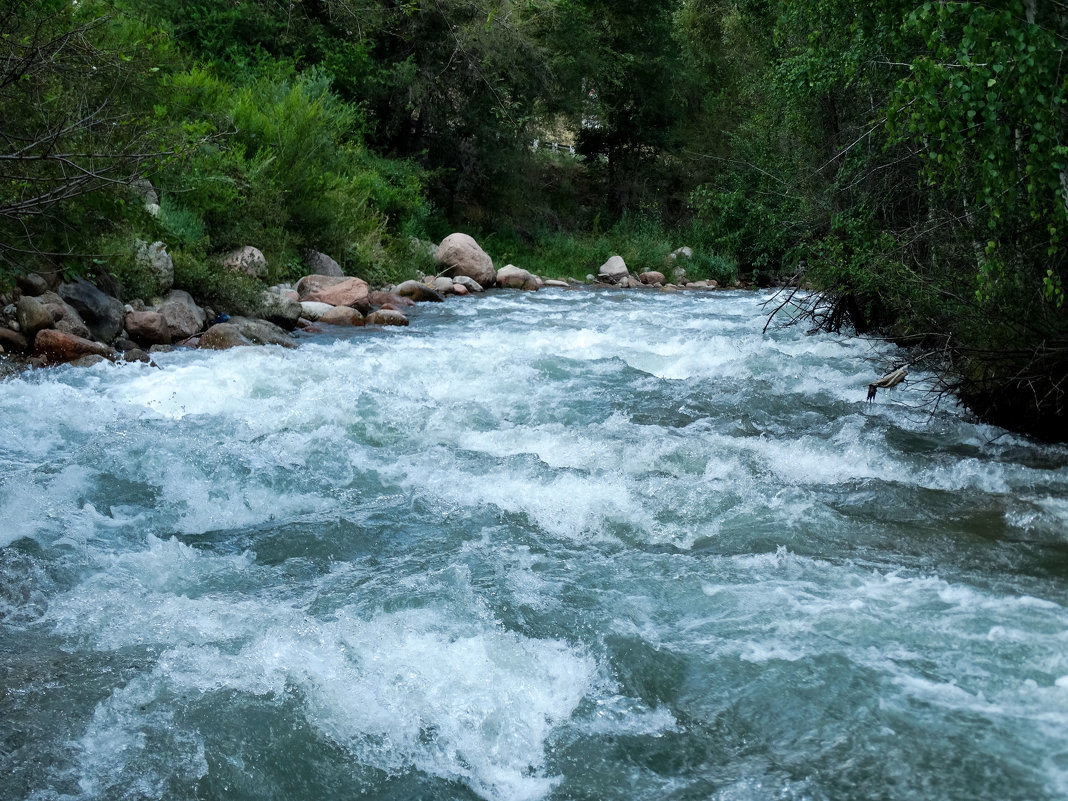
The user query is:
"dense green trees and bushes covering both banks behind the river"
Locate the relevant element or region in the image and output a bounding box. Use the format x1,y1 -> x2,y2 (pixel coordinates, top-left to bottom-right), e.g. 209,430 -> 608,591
0,0 -> 1068,439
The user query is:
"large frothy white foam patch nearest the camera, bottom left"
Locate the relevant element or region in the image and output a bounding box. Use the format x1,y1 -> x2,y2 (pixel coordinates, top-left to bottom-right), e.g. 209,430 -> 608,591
43,538 -> 602,801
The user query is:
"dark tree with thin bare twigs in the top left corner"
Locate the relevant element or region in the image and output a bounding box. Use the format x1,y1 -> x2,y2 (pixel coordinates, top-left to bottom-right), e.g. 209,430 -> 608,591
0,0 -> 164,272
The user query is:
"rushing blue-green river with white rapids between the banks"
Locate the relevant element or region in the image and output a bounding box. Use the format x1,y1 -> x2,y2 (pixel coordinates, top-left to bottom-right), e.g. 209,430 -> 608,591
0,290 -> 1068,801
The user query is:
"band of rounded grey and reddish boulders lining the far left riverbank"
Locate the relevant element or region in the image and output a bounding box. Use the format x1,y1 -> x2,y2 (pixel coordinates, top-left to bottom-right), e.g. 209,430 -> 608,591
0,234 -> 734,375
